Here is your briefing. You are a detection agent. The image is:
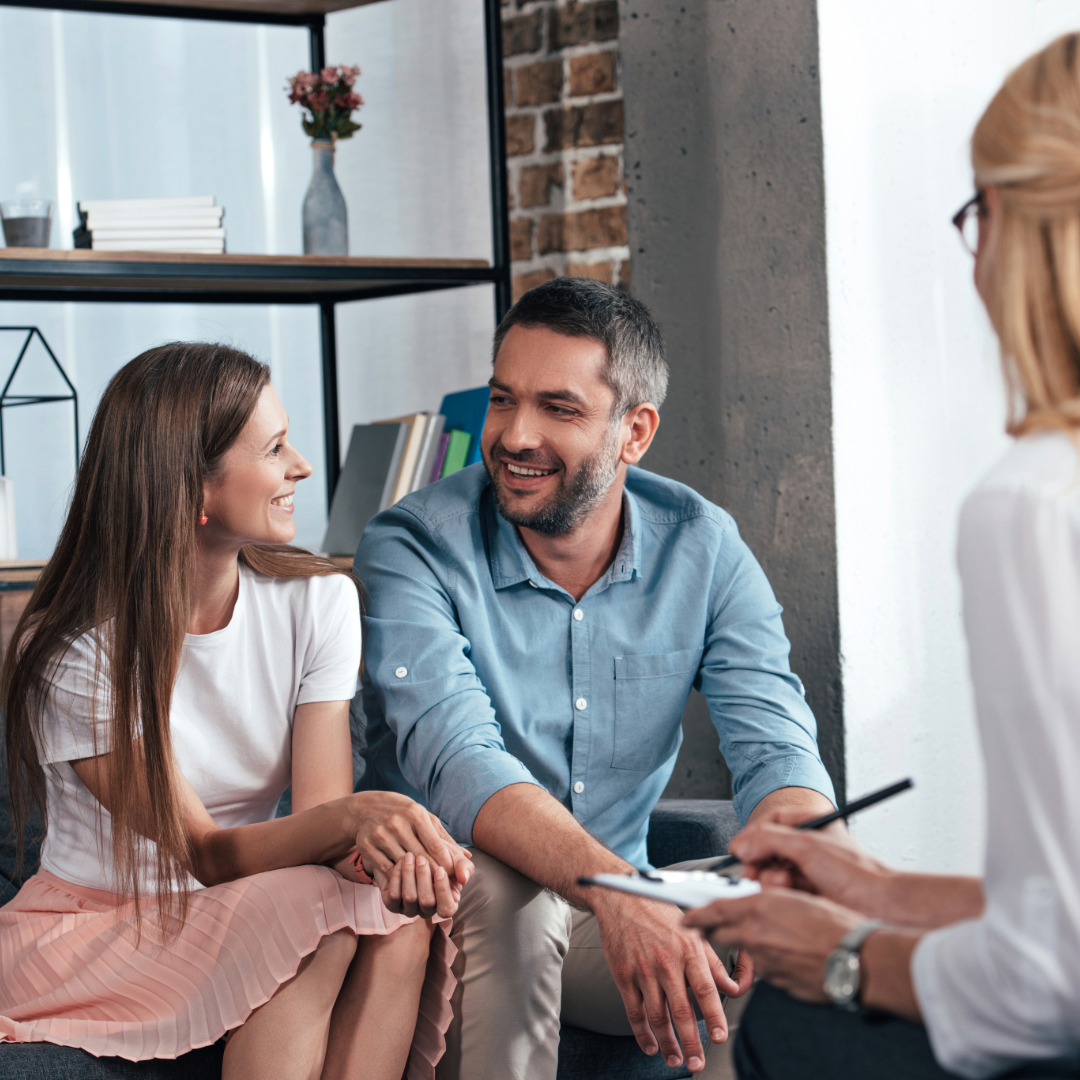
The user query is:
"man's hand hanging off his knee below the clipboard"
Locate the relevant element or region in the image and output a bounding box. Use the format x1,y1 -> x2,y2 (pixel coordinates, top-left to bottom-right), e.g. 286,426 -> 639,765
593,894 -> 753,1072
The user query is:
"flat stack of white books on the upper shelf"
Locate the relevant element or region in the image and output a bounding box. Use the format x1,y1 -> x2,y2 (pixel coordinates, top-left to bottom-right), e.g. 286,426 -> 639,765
75,195 -> 225,255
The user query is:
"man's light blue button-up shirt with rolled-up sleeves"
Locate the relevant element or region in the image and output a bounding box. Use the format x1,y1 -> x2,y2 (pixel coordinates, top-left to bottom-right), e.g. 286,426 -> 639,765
355,464 -> 834,866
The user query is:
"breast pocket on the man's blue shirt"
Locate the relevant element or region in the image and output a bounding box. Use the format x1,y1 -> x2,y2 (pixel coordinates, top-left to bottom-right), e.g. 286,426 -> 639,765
611,649 -> 703,772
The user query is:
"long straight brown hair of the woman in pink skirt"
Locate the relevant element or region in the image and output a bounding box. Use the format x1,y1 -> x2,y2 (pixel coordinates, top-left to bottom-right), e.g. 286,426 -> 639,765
0,342 -> 347,919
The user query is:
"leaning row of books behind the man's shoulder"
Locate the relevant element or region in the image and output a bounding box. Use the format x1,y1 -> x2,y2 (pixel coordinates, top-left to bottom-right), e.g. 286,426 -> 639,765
323,387 -> 490,555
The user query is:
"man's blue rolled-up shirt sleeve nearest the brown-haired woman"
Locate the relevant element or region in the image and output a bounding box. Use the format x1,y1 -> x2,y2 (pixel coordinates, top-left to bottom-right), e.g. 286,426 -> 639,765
355,508 -> 542,843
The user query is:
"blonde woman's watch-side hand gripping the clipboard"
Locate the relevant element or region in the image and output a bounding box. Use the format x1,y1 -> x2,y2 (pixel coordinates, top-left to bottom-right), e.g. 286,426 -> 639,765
686,889 -> 865,1001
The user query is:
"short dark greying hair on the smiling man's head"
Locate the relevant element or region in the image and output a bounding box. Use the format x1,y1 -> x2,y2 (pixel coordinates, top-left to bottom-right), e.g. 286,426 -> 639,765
491,278 -> 667,419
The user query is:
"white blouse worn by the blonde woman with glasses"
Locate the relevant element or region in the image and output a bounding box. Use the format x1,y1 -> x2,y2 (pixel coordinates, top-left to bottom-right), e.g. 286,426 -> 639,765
912,432 -> 1080,1078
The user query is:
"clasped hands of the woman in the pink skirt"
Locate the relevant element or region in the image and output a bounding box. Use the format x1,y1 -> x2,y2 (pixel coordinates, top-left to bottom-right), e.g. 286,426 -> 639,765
333,792 -> 473,919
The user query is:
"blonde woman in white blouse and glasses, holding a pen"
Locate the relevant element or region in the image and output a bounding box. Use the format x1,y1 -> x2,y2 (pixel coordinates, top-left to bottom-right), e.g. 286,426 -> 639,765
688,35 -> 1080,1080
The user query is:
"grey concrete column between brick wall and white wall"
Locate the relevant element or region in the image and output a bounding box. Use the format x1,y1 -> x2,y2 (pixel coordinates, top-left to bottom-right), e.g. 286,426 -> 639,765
620,0 -> 845,798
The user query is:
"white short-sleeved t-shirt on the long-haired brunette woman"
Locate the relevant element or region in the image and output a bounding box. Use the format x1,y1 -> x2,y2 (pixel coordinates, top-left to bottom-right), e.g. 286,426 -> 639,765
35,565 -> 361,894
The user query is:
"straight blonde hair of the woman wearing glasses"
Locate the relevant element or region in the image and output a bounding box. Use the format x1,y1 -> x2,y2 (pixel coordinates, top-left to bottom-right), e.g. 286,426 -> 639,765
971,33 -> 1080,434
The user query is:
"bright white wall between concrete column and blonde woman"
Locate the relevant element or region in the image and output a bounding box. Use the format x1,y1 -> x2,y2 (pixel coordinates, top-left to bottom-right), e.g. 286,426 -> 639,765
818,0 -> 1080,872
